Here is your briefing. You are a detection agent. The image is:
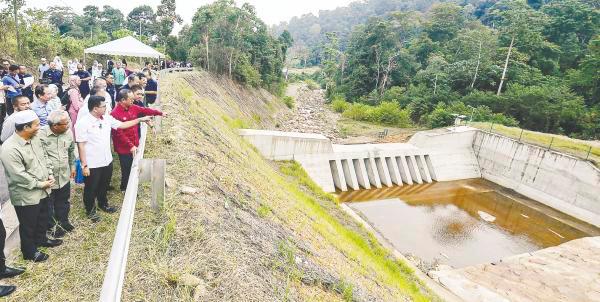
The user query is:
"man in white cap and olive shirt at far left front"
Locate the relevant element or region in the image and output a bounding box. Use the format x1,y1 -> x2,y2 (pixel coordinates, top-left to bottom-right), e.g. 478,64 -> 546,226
0,110 -> 62,262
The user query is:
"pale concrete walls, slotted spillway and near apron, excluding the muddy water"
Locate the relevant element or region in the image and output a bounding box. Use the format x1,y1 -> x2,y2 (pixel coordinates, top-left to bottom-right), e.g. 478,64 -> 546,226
240,126 -> 600,301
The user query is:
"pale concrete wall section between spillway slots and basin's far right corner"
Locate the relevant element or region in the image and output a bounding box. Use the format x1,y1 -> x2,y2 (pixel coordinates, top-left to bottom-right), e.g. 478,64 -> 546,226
408,127 -> 481,181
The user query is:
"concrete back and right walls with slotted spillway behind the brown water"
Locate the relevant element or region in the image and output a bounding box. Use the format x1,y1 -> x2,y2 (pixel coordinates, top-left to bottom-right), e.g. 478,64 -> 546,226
240,126 -> 600,227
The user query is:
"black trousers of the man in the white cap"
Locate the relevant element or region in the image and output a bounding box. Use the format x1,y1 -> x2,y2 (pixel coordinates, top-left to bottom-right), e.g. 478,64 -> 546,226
15,197 -> 48,258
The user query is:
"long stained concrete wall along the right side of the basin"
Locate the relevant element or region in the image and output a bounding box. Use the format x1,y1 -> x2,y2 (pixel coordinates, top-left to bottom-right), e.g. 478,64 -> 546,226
473,131 -> 600,226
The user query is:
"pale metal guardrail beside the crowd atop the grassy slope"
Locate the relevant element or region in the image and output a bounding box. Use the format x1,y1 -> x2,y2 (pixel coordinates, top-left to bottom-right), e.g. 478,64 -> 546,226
99,68 -> 193,302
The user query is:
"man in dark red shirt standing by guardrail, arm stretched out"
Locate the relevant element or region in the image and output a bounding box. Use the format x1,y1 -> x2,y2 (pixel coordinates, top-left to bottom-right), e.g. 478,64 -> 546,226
110,87 -> 164,191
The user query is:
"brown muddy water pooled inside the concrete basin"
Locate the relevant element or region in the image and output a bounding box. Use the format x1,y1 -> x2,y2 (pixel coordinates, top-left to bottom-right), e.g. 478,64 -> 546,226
338,179 -> 600,267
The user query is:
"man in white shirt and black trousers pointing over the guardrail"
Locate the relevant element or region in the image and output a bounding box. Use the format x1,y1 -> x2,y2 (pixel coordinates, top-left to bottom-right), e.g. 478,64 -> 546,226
75,95 -> 150,222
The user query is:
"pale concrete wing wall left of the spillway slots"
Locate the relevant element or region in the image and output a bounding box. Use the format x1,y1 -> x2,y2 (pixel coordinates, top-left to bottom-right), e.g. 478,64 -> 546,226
239,129 -> 333,160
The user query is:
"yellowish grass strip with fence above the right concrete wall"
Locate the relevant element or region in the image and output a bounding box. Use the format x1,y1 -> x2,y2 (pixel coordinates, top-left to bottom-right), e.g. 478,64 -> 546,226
470,122 -> 600,166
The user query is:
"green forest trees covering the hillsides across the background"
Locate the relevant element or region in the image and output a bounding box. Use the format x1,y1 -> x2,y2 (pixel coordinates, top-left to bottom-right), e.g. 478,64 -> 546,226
0,0 -> 600,139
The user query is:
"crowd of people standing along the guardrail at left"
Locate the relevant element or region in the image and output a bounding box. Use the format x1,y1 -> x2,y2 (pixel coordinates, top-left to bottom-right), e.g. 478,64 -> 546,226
0,55 -> 164,297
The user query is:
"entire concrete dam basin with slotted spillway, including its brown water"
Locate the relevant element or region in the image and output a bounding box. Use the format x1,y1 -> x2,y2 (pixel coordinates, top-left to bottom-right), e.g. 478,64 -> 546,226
239,126 -> 600,301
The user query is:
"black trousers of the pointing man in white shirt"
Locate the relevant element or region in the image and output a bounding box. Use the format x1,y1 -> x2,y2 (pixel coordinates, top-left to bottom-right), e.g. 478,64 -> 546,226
83,163 -> 112,215
